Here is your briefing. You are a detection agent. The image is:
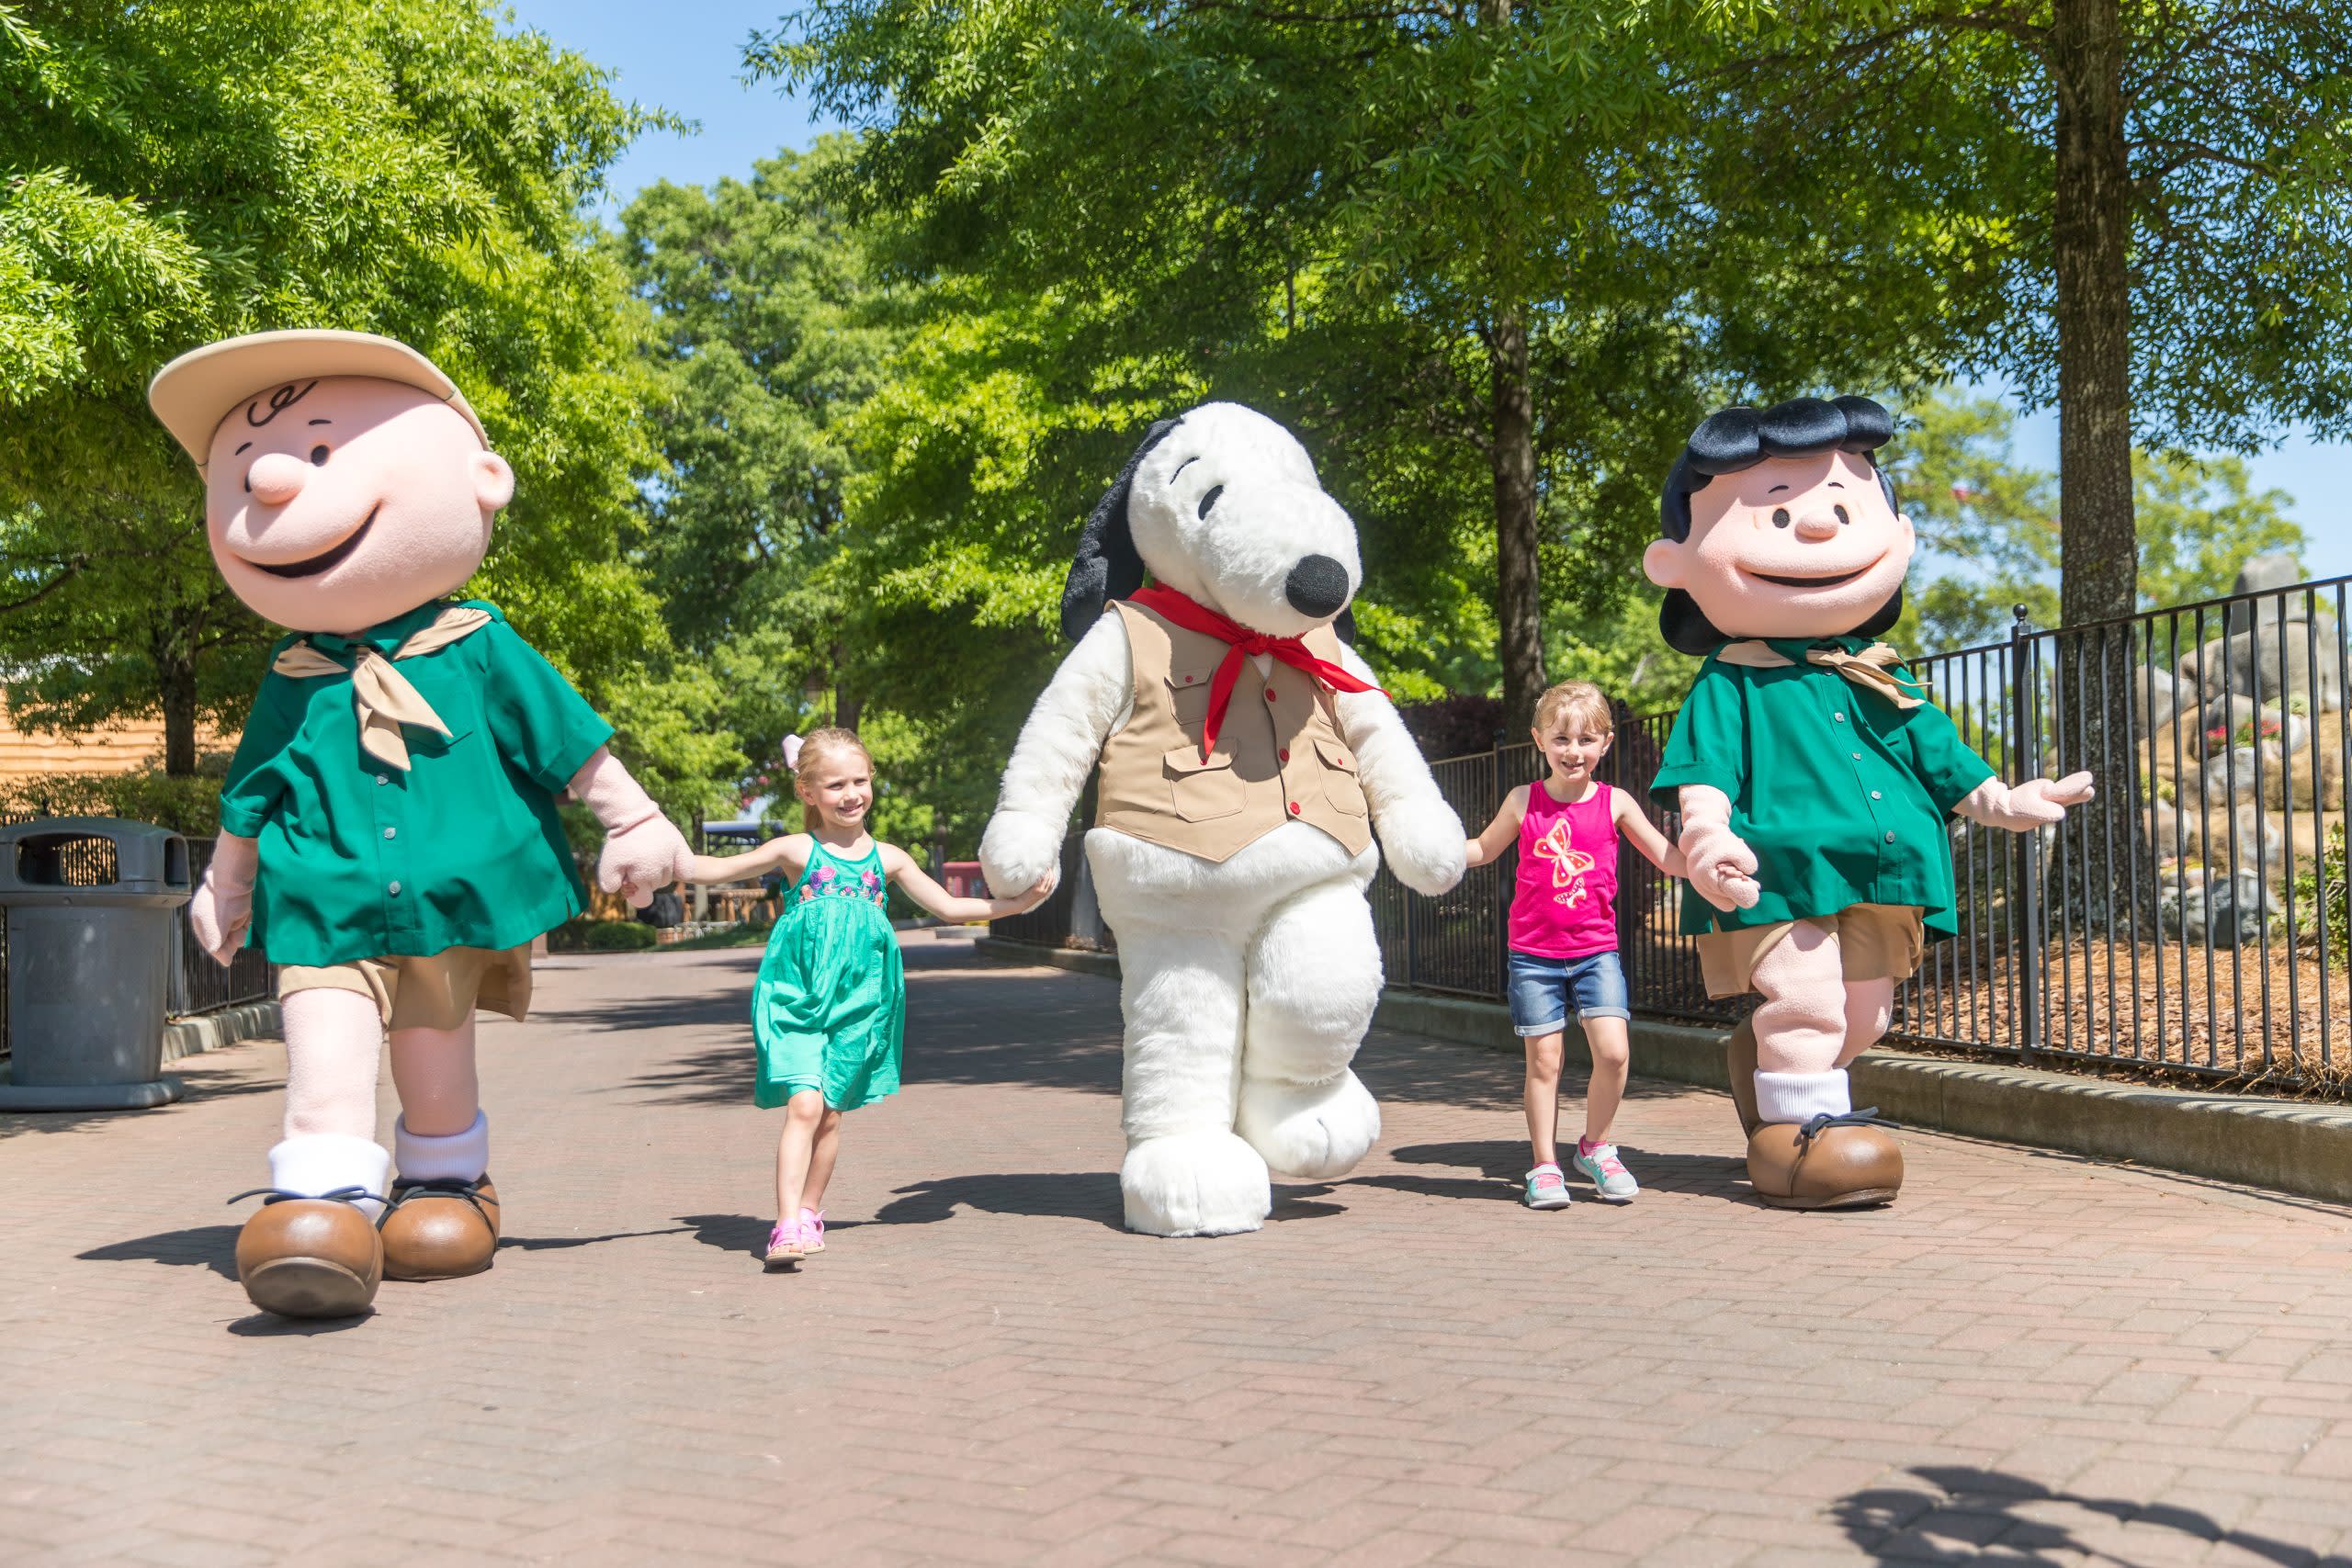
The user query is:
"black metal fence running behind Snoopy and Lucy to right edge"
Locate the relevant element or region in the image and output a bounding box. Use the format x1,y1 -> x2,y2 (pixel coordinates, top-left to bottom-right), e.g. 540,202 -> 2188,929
997,579 -> 2352,1093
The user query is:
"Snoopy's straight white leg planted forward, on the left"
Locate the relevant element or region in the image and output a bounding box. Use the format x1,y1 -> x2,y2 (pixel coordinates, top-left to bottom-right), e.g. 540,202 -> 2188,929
1114,919 -> 1272,1236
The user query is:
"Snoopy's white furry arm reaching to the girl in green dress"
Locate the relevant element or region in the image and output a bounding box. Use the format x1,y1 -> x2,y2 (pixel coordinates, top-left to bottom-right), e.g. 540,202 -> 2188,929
981,616 -> 1136,898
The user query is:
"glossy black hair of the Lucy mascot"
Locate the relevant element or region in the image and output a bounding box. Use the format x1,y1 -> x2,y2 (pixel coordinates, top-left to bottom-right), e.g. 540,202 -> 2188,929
1658,398 -> 1903,653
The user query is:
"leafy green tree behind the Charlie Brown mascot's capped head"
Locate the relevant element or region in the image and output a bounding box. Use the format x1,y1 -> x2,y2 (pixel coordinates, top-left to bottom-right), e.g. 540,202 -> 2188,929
0,0 -> 698,808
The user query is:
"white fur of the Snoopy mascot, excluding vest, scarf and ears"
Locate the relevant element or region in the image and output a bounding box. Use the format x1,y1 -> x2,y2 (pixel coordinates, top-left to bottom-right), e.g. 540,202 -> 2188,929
981,404 -> 1465,1236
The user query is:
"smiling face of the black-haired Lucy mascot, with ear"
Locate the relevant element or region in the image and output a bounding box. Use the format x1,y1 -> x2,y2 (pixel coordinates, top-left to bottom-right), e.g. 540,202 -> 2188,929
1642,451 -> 1915,637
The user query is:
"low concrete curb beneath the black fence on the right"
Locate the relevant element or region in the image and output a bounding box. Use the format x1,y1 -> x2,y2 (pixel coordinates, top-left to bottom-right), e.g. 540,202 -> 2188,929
978,938 -> 2352,1203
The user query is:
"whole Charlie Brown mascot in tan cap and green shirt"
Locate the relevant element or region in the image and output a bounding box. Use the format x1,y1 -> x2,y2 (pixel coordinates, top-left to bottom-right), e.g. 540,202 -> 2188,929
148,332 -> 687,1316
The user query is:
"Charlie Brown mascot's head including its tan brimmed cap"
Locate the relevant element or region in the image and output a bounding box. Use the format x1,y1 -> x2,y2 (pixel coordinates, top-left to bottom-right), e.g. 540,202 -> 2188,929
148,332 -> 515,632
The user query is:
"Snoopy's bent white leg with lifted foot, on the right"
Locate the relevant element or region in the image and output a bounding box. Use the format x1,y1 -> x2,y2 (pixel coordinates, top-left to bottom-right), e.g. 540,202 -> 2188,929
1239,869 -> 1381,1180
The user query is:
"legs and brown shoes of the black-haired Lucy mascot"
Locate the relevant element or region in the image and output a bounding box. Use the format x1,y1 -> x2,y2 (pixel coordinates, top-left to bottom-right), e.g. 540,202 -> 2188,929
1747,921 -> 1903,1208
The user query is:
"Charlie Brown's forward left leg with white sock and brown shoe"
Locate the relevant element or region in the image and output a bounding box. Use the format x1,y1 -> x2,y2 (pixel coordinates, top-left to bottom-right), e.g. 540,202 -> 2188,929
238,989 -> 393,1316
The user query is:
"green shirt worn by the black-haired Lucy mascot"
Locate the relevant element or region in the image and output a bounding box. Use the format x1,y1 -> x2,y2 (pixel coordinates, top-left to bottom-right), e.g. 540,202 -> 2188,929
1651,637 -> 1992,936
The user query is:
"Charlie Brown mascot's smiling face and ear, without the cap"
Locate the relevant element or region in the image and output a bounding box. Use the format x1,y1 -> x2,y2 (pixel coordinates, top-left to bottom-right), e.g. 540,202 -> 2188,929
205,376 -> 515,632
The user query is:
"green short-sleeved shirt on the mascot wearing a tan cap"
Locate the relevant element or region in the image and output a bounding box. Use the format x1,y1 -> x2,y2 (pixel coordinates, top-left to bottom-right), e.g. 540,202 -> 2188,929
221,600 -> 612,964
